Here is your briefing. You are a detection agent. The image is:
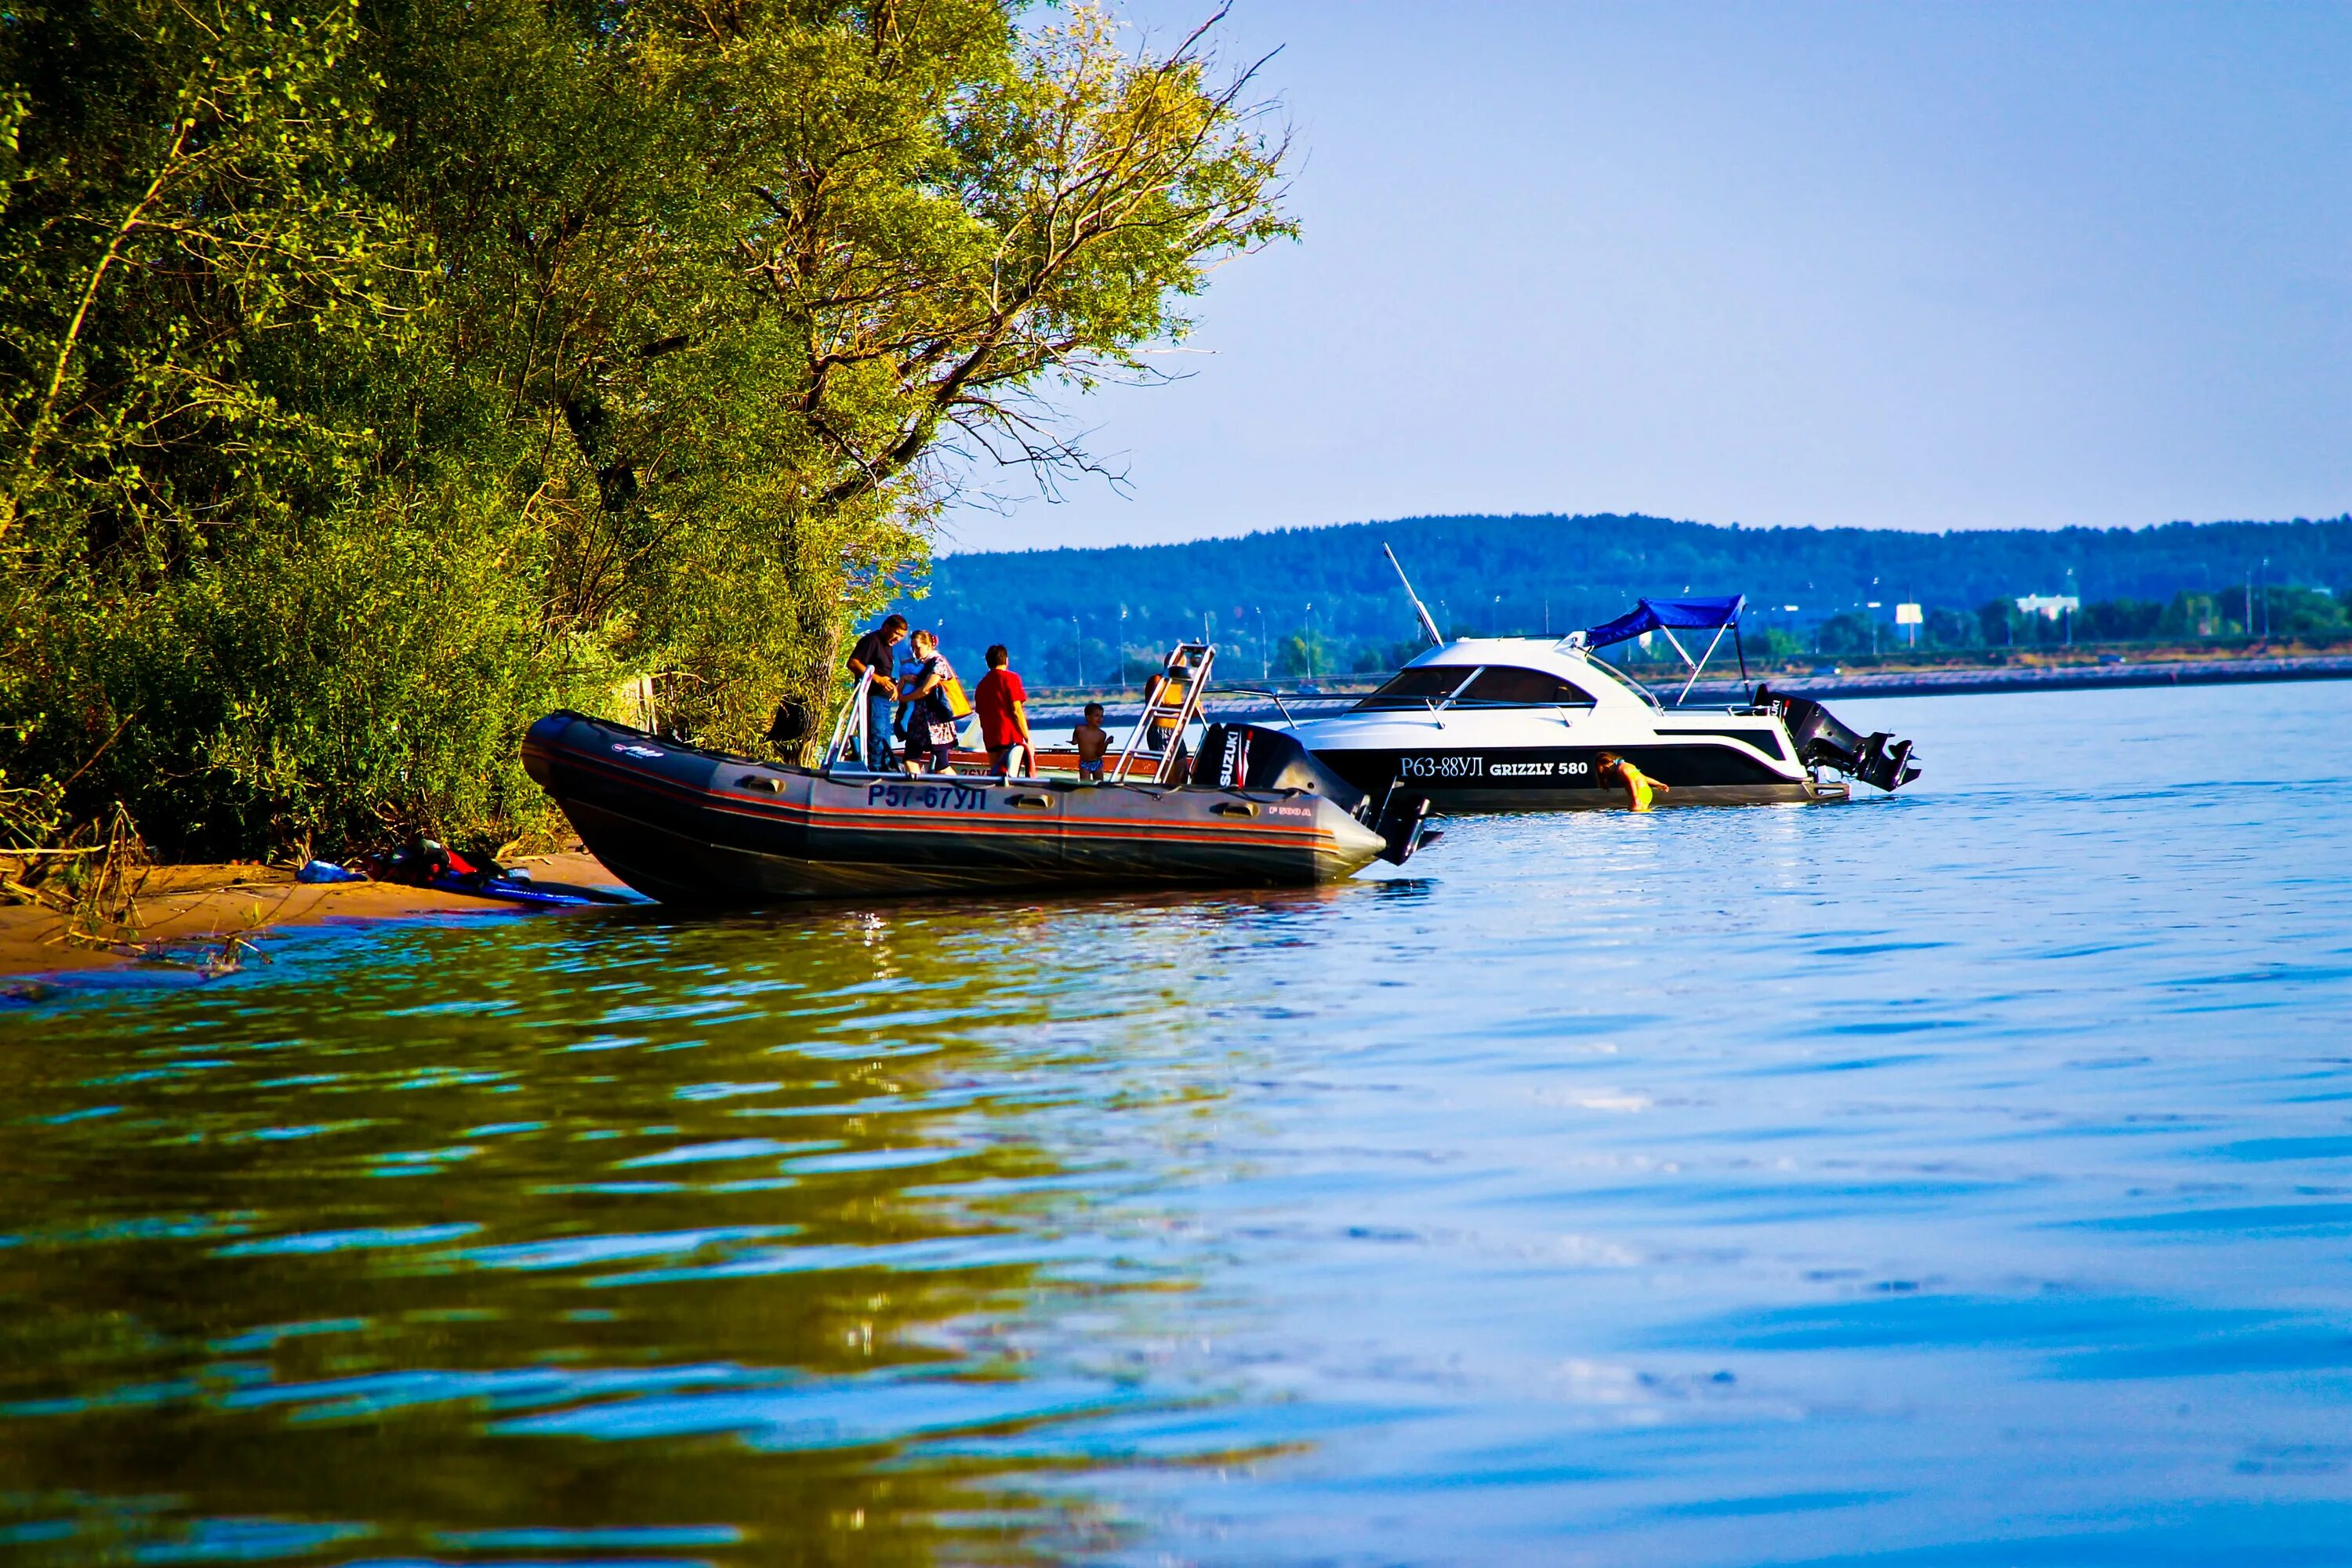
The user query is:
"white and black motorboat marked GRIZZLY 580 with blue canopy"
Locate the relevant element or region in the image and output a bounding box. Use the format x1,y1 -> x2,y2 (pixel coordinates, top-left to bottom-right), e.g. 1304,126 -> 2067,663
1261,555 -> 1919,811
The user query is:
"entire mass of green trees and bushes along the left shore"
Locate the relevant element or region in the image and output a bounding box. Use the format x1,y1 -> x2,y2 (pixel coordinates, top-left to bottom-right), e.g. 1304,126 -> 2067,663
0,0 -> 1291,853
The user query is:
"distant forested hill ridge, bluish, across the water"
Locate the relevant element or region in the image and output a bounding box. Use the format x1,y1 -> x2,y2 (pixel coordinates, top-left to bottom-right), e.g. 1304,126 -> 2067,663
901,515 -> 2352,682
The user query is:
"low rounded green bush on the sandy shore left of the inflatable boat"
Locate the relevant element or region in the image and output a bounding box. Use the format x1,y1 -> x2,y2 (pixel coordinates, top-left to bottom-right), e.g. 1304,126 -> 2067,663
0,499 -> 616,858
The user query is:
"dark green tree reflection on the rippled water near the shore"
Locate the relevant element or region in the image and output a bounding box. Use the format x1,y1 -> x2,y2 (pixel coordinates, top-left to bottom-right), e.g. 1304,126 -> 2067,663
0,888 -> 1381,1561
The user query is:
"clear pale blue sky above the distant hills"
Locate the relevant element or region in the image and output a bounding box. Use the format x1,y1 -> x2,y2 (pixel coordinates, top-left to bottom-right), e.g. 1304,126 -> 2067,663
941,0 -> 2352,550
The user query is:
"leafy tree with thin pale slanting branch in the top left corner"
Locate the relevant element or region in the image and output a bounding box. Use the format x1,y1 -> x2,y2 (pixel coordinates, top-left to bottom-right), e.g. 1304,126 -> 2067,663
0,0 -> 407,571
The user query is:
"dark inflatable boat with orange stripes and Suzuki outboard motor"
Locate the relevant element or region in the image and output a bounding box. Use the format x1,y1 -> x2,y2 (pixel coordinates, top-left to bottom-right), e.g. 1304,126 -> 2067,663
522,647 -> 1435,905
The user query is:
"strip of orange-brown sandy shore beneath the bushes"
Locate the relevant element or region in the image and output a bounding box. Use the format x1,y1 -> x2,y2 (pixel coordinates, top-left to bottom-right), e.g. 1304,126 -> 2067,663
0,853 -> 619,980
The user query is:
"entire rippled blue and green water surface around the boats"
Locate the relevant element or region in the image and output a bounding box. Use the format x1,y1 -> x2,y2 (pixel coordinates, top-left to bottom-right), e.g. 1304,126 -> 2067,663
0,684 -> 2352,1566
